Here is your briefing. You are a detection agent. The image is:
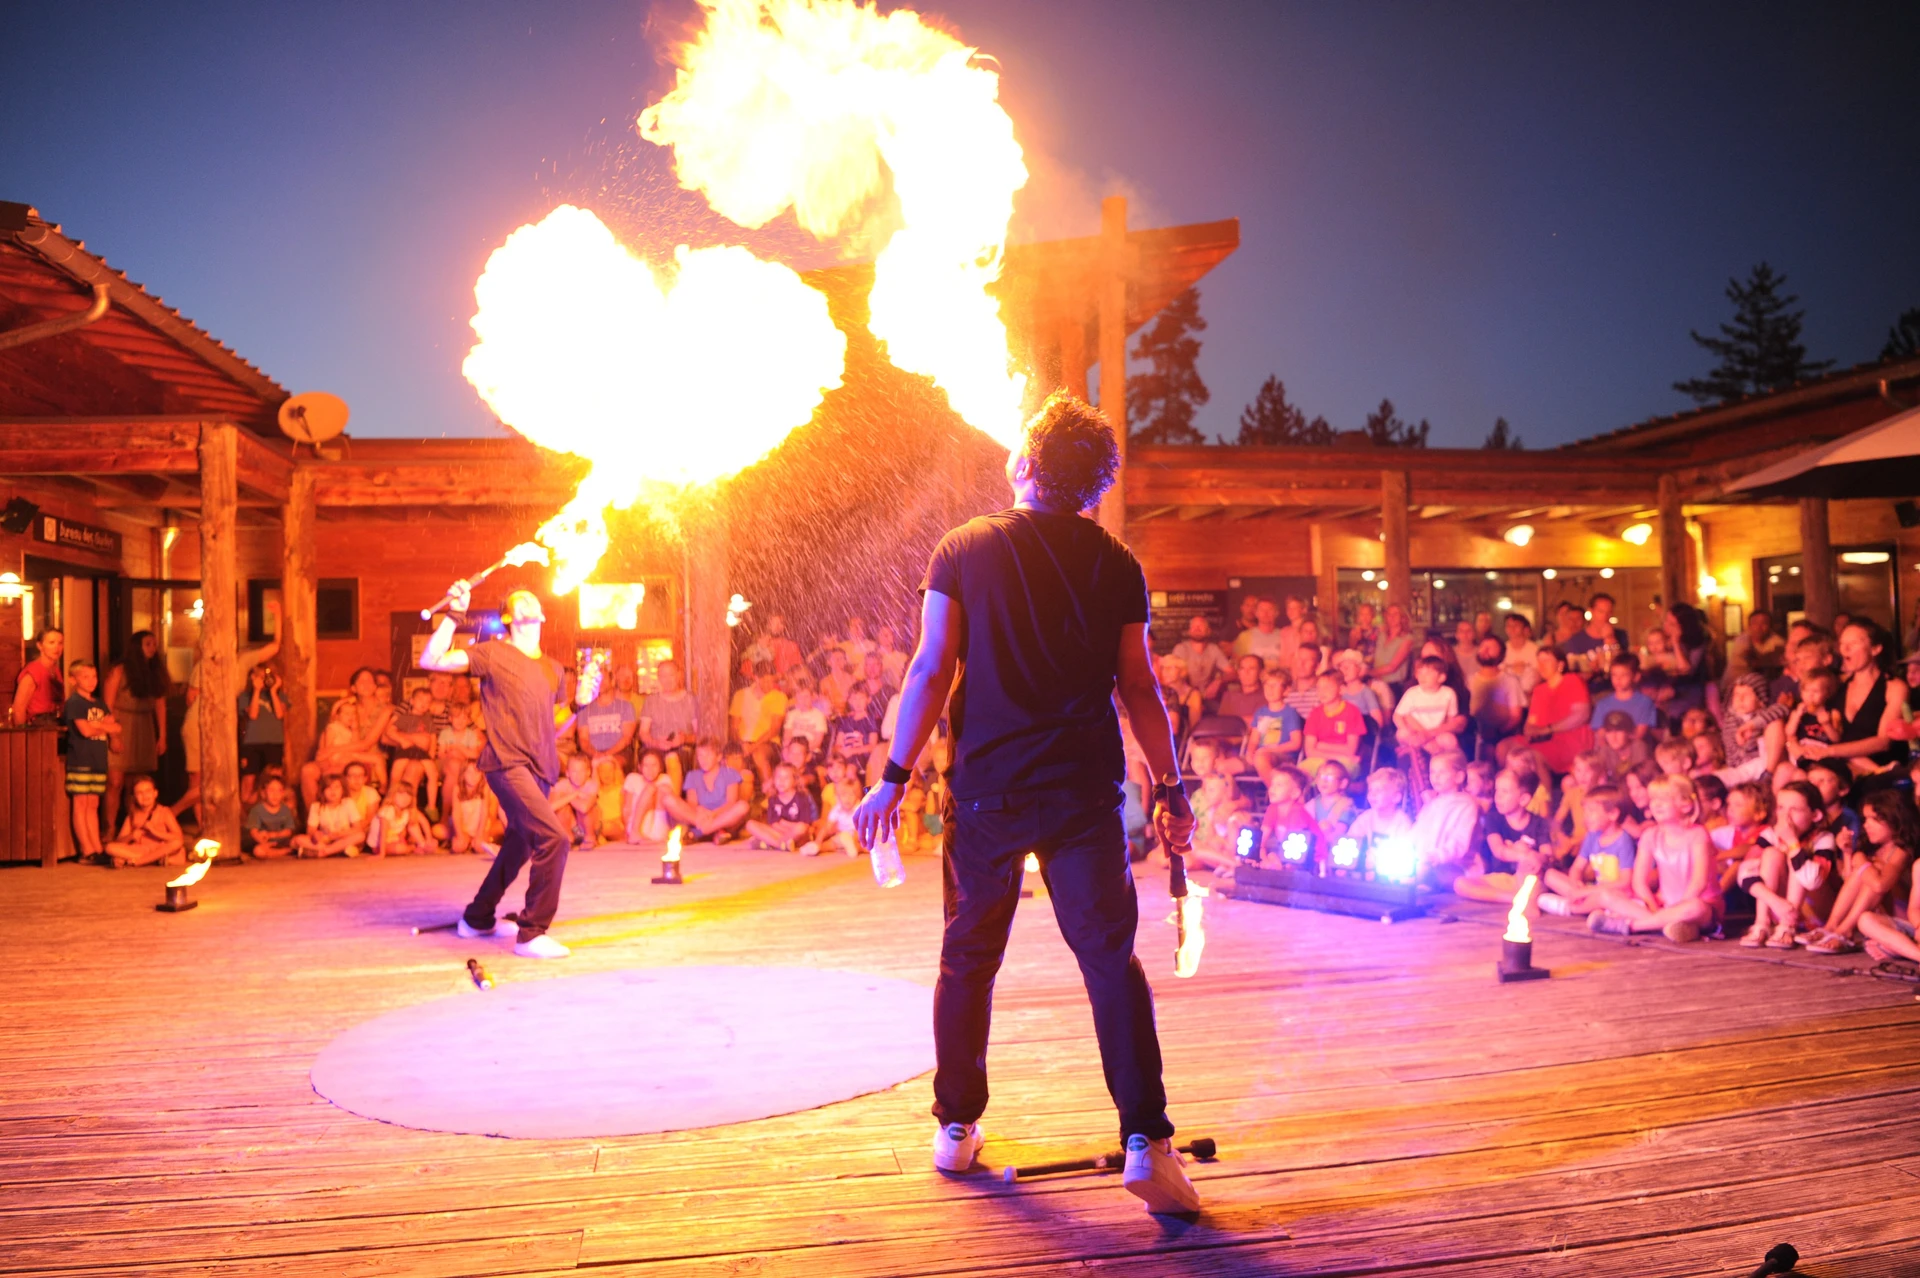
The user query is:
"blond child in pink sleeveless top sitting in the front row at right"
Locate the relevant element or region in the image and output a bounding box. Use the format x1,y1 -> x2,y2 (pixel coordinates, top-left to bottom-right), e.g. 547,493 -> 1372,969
1586,775 -> 1724,942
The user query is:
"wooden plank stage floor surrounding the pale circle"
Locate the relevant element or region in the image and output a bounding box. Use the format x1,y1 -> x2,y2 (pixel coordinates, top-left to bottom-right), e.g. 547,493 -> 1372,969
0,848 -> 1920,1278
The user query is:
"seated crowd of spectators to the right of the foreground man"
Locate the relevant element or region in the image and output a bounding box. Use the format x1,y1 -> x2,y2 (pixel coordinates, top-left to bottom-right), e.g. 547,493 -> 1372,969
1152,593 -> 1920,959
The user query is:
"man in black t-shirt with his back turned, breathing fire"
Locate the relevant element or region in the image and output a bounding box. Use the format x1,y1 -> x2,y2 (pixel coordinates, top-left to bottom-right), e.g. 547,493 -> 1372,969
854,393 -> 1200,1213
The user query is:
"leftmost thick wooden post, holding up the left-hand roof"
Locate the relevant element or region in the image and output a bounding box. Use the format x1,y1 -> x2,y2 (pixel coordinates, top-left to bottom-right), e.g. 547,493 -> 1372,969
196,422 -> 240,856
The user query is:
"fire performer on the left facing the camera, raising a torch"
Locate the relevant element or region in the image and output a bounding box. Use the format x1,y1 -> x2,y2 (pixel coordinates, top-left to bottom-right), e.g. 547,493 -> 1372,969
420,581 -> 570,958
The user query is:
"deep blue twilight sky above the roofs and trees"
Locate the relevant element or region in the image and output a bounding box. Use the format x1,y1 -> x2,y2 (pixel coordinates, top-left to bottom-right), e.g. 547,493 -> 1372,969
0,0 -> 1920,447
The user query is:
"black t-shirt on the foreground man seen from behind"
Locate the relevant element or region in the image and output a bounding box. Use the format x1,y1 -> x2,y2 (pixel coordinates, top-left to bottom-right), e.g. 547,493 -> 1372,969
920,509 -> 1146,798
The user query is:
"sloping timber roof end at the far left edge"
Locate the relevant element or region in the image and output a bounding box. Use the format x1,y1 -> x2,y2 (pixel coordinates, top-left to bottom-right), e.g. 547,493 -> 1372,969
0,205 -> 286,429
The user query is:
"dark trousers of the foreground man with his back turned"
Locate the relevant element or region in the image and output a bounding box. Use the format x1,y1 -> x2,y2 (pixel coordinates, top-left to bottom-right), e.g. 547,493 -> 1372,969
933,791 -> 1173,1142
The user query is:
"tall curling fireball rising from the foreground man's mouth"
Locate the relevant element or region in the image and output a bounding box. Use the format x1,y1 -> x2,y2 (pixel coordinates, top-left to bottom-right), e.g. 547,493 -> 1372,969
639,0 -> 1027,445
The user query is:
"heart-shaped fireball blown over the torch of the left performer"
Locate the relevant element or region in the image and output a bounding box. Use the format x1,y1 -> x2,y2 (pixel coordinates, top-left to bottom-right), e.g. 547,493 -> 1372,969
461,205 -> 847,595
